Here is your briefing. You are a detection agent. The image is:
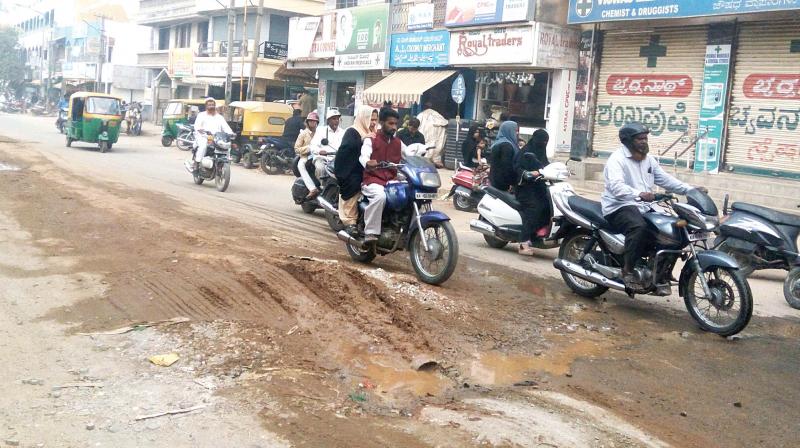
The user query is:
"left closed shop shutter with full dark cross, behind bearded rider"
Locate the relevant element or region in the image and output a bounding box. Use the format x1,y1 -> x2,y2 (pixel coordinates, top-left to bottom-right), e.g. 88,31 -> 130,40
592,26 -> 707,165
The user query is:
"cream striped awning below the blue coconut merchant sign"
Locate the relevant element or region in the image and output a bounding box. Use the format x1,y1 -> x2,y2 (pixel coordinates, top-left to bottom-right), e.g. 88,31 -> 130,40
364,70 -> 456,104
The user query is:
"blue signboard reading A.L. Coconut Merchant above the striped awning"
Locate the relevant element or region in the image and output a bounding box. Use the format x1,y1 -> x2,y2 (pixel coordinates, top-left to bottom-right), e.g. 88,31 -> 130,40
389,31 -> 450,68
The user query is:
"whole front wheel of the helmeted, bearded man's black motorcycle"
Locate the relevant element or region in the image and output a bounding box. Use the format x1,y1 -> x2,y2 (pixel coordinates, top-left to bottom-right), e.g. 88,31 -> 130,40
682,267 -> 753,336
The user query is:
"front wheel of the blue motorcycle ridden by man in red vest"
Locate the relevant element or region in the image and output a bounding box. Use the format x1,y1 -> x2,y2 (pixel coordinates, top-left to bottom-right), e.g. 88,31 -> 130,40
409,221 -> 458,285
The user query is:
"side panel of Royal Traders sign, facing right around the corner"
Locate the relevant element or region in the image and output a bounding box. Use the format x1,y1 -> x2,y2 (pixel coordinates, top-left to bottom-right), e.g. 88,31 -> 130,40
533,22 -> 581,70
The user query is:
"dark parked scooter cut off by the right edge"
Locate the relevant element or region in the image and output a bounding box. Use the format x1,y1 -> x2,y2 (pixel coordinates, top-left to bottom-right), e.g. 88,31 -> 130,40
714,195 -> 800,309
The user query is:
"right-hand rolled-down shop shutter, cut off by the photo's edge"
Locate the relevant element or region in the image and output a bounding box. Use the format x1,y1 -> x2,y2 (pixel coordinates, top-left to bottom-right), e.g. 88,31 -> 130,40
724,22 -> 800,177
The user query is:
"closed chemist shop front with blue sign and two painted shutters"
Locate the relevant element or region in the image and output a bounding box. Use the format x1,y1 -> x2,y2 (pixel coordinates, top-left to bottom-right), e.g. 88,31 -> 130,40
569,0 -> 800,179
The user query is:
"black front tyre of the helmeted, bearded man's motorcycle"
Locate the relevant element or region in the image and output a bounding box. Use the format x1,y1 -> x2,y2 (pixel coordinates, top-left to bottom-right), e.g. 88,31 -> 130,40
681,267 -> 753,337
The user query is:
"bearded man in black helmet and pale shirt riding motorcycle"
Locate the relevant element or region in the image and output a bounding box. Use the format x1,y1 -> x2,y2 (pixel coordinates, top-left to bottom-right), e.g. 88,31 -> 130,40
601,122 -> 707,287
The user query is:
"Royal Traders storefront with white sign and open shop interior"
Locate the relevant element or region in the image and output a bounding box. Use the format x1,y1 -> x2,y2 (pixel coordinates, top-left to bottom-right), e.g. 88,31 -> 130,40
450,22 -> 579,153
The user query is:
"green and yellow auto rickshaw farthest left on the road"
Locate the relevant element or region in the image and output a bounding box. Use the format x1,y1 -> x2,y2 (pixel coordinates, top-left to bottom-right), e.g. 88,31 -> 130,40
66,92 -> 122,152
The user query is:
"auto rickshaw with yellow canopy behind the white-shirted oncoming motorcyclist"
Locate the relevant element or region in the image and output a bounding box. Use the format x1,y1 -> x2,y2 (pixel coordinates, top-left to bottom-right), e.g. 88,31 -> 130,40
229,101 -> 294,169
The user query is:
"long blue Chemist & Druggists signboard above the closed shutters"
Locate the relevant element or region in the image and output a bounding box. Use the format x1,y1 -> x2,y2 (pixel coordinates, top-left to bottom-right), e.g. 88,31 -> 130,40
569,0 -> 800,23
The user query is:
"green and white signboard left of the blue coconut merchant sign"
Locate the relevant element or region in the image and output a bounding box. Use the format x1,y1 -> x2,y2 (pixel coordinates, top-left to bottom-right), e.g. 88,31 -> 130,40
333,3 -> 390,70
